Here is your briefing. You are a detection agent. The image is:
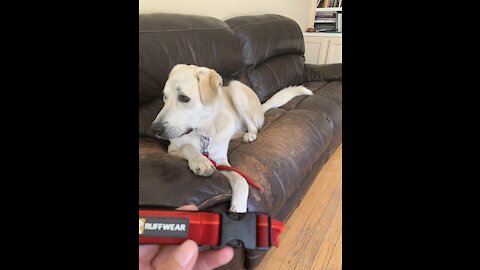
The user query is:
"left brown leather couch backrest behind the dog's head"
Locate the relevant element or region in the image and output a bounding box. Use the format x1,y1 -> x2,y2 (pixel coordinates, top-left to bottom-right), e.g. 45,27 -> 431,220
139,13 -> 244,135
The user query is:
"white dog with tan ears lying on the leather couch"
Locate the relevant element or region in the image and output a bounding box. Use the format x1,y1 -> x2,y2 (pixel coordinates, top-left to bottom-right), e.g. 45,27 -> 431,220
152,64 -> 313,213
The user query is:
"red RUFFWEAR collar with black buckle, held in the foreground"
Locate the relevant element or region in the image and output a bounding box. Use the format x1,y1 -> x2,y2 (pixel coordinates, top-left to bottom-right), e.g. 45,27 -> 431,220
139,209 -> 285,250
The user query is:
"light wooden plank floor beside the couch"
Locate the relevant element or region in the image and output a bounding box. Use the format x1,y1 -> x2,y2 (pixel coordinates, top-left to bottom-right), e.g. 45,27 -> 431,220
255,145 -> 342,270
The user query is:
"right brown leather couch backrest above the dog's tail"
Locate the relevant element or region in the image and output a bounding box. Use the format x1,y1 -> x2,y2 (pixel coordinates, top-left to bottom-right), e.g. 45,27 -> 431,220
225,14 -> 305,102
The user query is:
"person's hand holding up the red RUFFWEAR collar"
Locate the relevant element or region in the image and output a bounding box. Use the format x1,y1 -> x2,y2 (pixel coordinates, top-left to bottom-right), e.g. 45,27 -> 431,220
138,205 -> 233,270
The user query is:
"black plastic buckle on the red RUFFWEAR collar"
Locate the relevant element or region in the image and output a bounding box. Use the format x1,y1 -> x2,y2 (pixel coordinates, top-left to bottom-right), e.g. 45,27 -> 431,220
212,212 -> 272,250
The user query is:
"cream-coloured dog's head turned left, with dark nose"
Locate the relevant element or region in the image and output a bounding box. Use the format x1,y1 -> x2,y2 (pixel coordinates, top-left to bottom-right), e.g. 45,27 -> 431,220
151,64 -> 223,140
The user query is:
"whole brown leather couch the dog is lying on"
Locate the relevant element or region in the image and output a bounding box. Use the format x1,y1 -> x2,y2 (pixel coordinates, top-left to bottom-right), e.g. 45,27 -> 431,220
139,13 -> 342,269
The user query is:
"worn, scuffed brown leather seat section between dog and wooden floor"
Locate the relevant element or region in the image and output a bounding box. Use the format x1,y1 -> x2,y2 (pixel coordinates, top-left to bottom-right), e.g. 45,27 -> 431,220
229,82 -> 342,214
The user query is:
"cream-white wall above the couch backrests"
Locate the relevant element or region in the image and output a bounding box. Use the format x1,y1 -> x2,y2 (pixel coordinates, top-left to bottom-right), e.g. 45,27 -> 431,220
139,0 -> 316,31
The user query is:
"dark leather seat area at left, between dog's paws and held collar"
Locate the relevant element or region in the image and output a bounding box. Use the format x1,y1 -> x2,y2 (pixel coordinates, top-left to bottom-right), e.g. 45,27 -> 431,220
139,137 -> 231,209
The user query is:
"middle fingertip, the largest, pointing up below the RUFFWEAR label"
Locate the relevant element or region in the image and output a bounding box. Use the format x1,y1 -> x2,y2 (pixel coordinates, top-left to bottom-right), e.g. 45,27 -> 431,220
152,240 -> 198,270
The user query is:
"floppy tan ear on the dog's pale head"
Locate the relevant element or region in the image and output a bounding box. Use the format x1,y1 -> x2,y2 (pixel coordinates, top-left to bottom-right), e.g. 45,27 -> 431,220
197,67 -> 223,104
